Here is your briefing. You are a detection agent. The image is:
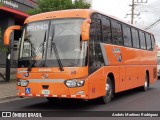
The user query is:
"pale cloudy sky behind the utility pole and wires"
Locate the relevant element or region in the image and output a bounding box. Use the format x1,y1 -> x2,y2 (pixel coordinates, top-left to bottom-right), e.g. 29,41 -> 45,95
92,0 -> 160,46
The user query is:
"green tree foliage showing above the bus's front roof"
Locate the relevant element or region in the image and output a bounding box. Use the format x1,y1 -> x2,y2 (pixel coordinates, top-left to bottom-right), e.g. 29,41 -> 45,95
27,0 -> 91,15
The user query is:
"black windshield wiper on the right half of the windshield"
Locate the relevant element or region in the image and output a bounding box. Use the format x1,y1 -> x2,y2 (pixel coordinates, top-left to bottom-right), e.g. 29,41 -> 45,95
51,39 -> 64,71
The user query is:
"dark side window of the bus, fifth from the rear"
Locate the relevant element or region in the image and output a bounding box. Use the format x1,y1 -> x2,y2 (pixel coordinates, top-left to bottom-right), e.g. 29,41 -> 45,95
123,25 -> 132,47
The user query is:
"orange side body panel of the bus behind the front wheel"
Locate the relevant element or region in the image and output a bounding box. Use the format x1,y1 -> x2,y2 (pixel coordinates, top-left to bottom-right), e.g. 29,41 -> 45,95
104,44 -> 156,92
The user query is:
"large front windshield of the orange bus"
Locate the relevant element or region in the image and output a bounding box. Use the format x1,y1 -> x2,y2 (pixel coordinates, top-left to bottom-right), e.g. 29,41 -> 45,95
18,19 -> 88,67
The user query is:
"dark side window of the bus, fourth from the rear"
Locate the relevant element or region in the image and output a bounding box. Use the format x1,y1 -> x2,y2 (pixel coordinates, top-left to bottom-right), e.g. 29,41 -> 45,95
132,28 -> 139,48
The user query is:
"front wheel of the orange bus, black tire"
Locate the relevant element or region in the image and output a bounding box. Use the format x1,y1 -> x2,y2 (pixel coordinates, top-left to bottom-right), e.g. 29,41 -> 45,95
100,77 -> 113,104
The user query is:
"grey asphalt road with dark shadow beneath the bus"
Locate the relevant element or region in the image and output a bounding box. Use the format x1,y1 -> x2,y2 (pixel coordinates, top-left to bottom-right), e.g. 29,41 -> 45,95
0,80 -> 160,117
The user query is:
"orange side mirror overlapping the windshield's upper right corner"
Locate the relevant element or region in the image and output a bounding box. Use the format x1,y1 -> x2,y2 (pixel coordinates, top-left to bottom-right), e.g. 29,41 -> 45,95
81,19 -> 91,41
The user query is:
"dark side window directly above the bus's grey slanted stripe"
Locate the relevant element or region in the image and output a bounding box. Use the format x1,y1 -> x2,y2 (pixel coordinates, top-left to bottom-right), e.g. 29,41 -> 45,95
102,17 -> 112,43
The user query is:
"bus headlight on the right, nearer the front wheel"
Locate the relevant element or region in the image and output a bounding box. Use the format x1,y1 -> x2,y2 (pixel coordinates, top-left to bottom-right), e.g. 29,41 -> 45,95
64,79 -> 85,88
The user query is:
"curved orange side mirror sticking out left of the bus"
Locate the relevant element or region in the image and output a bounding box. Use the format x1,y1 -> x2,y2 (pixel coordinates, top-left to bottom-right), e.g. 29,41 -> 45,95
4,25 -> 22,46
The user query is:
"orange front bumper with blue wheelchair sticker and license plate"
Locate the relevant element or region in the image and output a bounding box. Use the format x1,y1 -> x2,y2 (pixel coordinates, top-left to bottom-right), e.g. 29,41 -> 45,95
17,80 -> 88,99
